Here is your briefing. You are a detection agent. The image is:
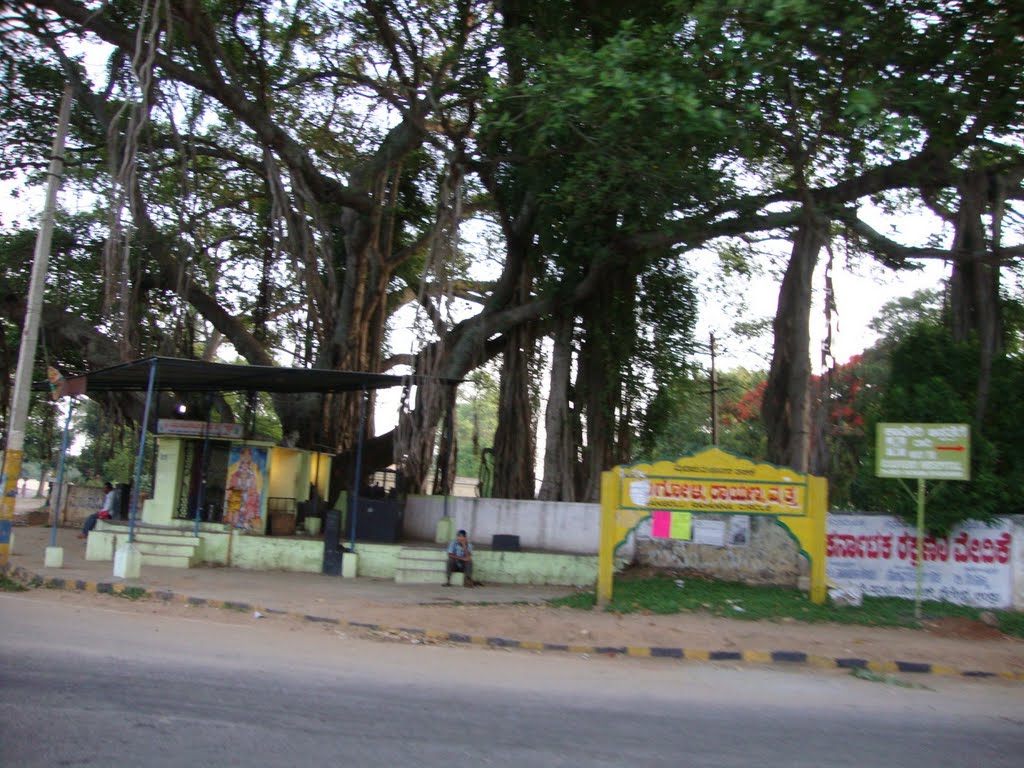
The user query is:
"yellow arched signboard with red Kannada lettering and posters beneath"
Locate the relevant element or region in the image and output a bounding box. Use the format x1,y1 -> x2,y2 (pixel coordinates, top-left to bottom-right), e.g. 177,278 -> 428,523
597,449 -> 827,603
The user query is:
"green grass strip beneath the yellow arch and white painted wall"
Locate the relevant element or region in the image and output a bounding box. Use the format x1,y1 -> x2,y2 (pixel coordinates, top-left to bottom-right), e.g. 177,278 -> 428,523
549,574 -> 1024,637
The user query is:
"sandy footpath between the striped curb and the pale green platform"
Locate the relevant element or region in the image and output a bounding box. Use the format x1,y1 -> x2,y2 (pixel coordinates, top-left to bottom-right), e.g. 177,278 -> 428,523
8,500 -> 1024,681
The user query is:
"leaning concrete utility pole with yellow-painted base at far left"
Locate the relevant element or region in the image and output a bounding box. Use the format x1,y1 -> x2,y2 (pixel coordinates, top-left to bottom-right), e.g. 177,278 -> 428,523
0,85 -> 71,567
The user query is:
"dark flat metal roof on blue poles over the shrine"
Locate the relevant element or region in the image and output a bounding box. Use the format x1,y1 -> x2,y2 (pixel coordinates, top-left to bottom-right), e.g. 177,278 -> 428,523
33,357 -> 413,394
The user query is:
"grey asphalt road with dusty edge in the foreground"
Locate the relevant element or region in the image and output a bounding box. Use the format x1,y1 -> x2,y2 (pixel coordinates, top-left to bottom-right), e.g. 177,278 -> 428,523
0,594 -> 1024,768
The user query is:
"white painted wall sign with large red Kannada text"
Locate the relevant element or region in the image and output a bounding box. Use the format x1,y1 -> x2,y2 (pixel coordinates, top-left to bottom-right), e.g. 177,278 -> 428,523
826,515 -> 1013,608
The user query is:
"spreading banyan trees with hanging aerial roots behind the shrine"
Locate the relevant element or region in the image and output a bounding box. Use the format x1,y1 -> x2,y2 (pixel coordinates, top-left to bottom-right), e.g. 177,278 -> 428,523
0,0 -> 1024,500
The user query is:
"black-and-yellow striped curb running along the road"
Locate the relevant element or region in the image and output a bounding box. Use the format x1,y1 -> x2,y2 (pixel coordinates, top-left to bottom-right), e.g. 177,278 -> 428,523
8,565 -> 1024,681
